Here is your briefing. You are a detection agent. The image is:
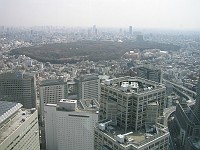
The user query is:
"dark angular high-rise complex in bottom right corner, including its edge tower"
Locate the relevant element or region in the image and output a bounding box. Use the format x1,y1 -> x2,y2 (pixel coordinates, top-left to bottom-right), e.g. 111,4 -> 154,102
175,72 -> 200,149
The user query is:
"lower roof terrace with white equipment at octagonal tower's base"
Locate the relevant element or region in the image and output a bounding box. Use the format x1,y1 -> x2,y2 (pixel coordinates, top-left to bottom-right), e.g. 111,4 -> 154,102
96,120 -> 169,147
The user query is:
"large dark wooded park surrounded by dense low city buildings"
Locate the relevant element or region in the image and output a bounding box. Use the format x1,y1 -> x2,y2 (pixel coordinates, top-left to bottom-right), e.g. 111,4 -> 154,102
10,41 -> 179,63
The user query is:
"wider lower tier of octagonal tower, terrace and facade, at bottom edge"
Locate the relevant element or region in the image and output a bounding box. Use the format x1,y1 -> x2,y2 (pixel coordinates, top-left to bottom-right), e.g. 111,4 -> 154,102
94,120 -> 170,150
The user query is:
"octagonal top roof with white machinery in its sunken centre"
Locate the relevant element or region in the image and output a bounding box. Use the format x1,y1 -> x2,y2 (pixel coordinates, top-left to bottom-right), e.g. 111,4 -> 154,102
102,77 -> 165,94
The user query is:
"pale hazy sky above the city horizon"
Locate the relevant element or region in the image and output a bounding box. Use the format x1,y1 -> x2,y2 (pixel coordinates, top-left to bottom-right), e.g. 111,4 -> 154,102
0,0 -> 200,29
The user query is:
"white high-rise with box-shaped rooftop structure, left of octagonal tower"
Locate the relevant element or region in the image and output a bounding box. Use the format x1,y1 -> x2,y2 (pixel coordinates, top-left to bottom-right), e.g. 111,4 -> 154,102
44,99 -> 99,150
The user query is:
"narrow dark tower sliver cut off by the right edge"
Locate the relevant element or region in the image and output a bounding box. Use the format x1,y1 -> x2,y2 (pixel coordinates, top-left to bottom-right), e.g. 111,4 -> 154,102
194,71 -> 200,120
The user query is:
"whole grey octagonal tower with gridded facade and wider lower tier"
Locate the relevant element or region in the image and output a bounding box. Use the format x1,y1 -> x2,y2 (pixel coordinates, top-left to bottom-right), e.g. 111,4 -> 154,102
94,77 -> 169,150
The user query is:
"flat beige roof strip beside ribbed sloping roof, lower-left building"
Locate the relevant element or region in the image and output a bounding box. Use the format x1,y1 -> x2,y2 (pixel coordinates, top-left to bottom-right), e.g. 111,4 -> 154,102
0,106 -> 35,144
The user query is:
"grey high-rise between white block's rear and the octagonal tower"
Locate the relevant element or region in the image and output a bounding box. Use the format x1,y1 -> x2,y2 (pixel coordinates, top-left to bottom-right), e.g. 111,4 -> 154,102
75,74 -> 100,101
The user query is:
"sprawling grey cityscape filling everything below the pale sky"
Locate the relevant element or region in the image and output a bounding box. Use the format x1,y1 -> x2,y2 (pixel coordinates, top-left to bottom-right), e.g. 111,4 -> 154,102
0,20 -> 200,150
